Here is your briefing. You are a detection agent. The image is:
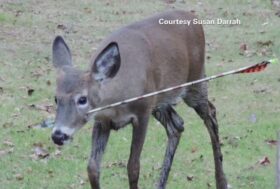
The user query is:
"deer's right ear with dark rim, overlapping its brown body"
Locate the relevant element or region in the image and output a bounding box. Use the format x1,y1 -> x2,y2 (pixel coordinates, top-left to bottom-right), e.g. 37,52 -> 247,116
91,42 -> 121,81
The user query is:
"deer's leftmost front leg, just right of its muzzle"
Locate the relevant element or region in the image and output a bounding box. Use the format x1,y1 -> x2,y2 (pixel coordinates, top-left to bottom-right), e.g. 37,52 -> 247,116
88,122 -> 110,189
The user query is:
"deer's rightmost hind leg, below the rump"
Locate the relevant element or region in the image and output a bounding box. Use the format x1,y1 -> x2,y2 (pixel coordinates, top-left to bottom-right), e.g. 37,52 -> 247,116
183,83 -> 227,189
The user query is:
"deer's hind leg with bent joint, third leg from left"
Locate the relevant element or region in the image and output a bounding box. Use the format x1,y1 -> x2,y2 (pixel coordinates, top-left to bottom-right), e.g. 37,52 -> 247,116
153,104 -> 184,189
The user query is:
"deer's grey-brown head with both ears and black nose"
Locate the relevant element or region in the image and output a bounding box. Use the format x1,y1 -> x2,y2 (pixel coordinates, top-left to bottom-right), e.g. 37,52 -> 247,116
52,36 -> 120,145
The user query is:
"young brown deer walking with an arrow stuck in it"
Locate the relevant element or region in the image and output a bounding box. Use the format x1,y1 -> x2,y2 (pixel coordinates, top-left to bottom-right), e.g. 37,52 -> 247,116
51,10 -> 228,189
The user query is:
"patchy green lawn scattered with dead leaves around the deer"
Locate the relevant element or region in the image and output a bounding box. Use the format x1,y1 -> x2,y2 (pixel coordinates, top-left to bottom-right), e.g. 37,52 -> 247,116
0,0 -> 280,189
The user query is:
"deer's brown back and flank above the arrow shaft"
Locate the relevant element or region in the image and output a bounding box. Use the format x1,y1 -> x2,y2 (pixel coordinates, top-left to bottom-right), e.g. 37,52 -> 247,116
92,11 -> 205,108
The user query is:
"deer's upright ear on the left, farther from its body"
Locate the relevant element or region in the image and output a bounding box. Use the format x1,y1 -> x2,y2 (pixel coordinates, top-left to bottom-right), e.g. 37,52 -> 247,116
52,36 -> 72,68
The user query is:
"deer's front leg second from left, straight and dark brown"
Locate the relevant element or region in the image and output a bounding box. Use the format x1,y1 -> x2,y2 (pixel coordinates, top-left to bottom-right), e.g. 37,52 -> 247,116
127,116 -> 149,189
